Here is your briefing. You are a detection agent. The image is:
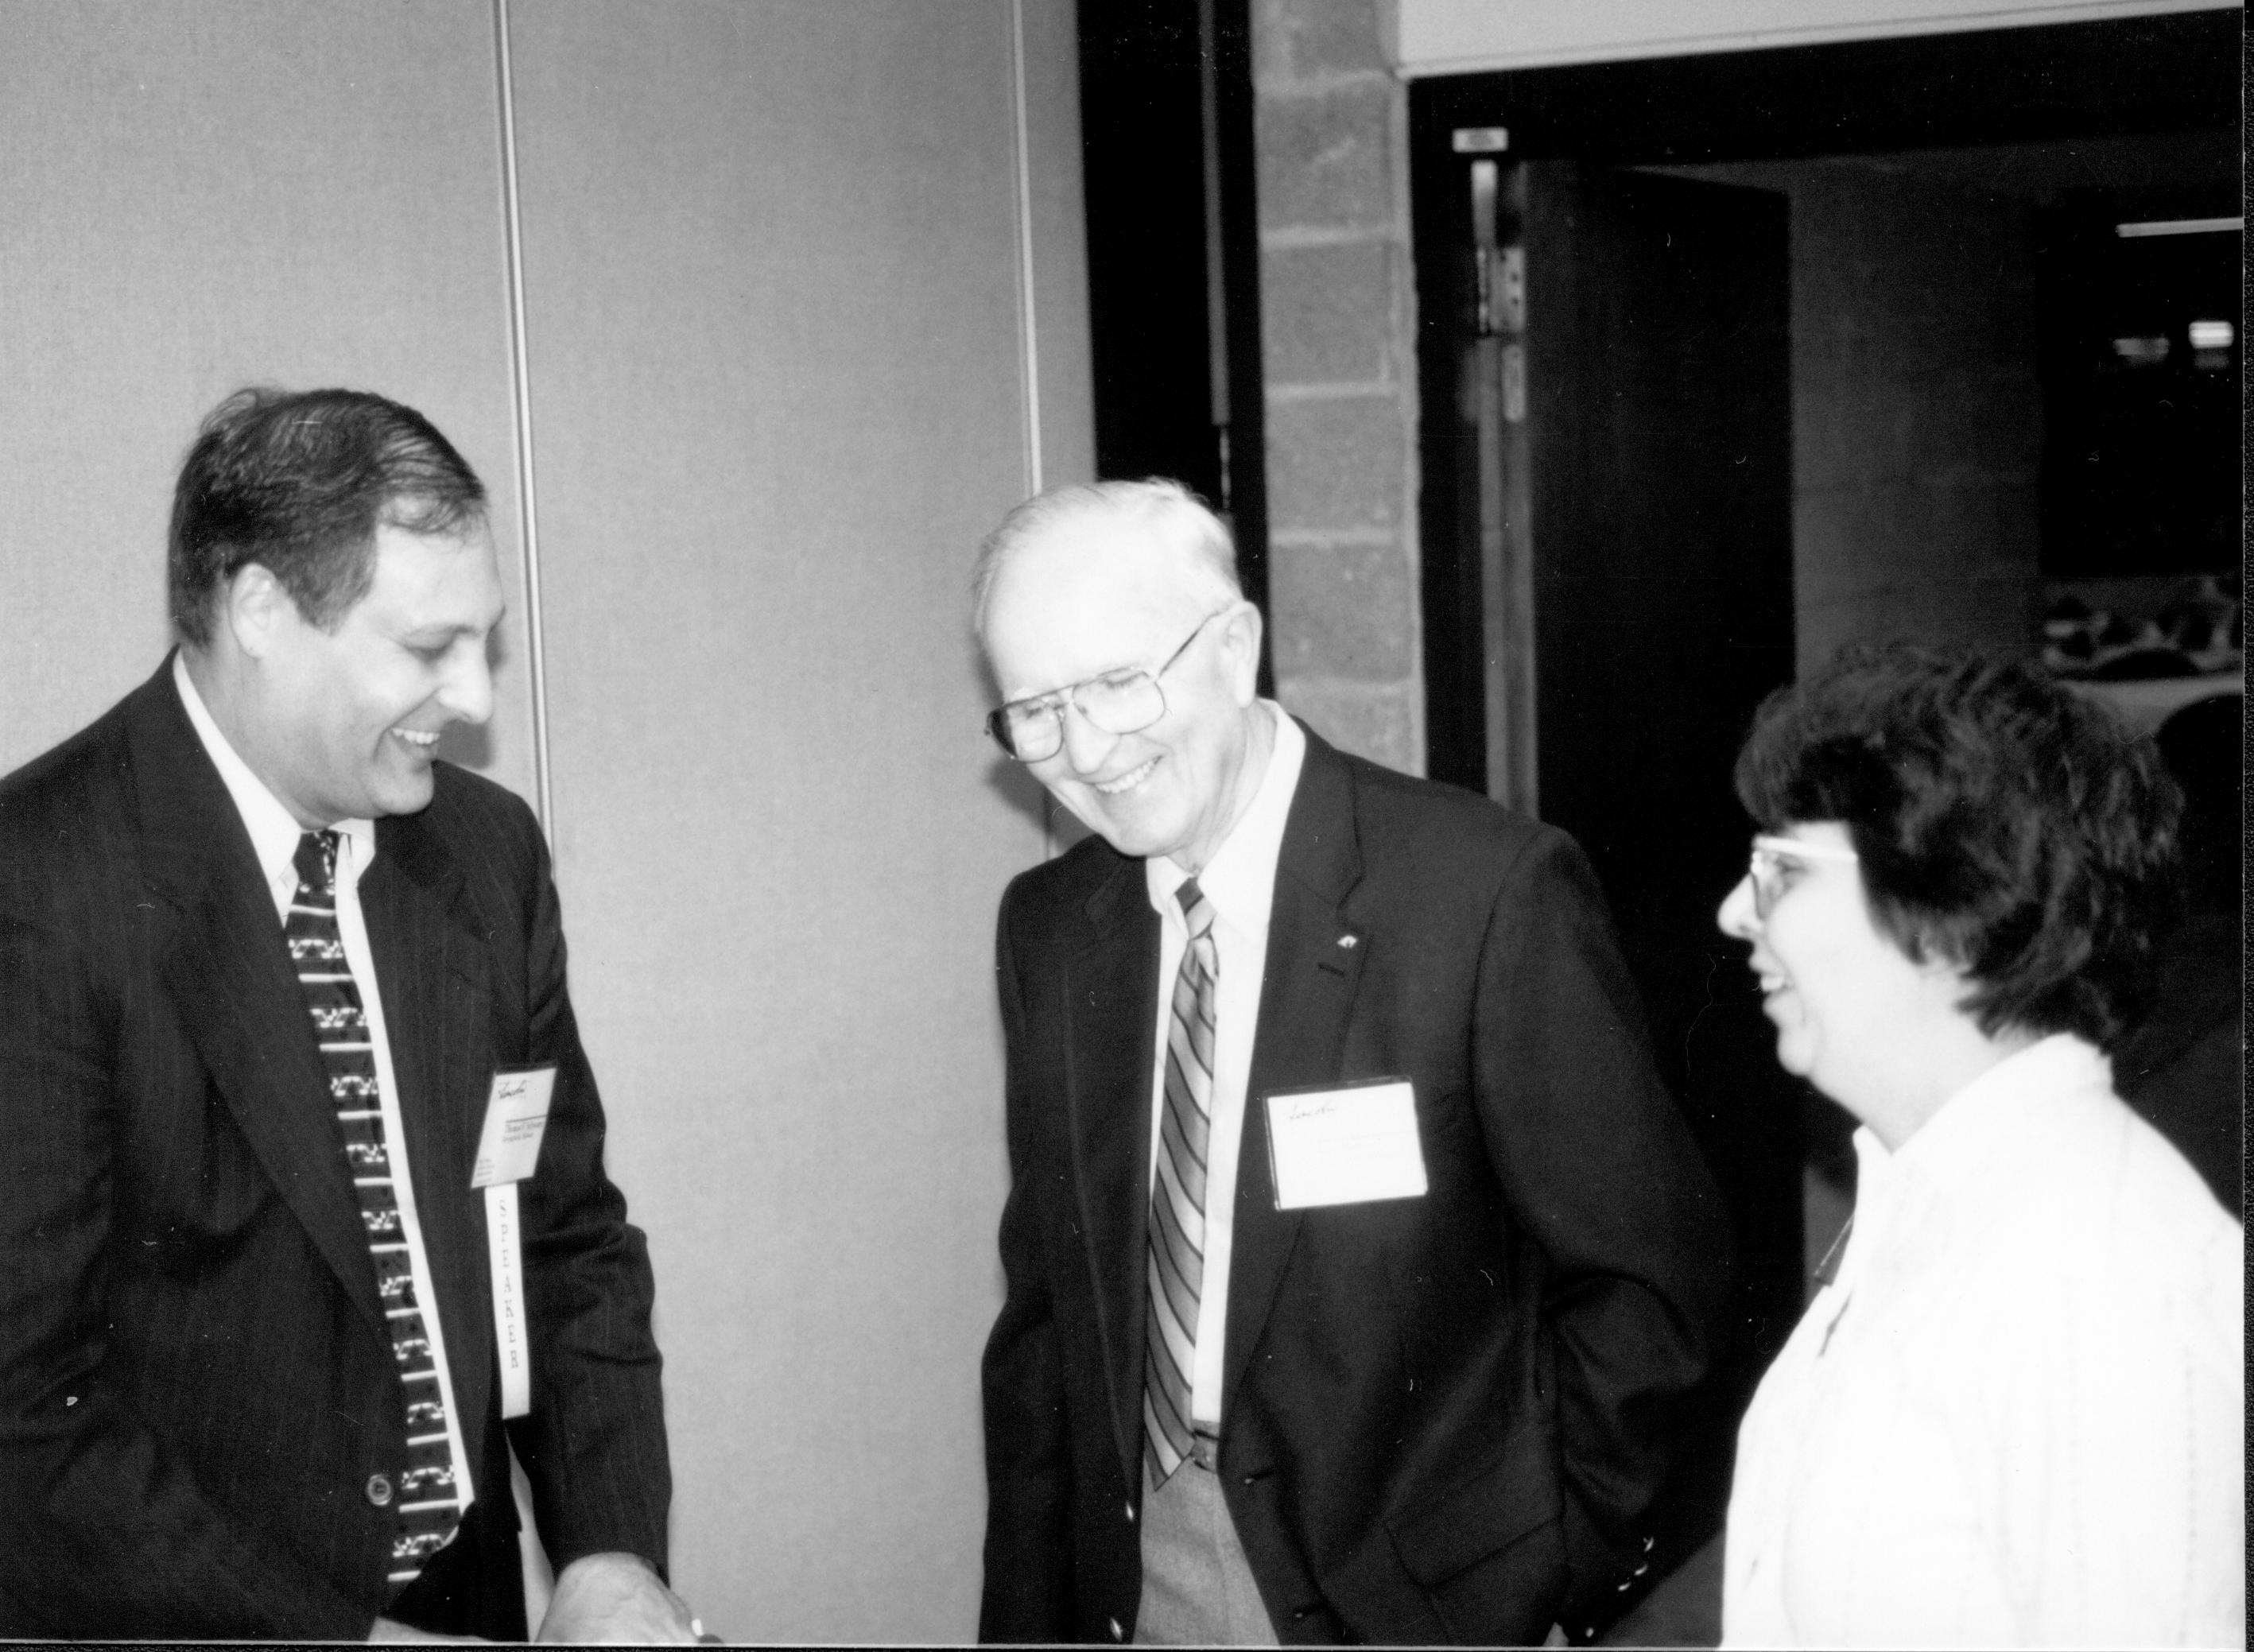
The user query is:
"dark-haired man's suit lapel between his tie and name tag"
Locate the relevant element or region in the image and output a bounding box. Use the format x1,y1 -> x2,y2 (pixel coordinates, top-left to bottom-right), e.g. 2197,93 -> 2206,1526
361,813 -> 496,1417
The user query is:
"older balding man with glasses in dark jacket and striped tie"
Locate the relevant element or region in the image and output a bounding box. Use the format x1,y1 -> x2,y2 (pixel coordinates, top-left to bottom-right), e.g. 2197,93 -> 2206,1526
974,483 -> 1731,1643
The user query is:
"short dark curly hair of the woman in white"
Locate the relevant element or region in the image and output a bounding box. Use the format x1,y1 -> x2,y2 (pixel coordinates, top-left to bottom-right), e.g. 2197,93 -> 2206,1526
1738,645 -> 2182,1048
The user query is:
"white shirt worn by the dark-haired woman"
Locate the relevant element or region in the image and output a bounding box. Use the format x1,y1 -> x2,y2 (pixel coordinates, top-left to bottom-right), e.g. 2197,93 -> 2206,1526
1722,1034 -> 2245,1647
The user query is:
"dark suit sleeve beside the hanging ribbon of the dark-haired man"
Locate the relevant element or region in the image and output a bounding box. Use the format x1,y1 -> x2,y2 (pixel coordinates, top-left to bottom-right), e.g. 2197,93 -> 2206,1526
493,800 -> 672,1573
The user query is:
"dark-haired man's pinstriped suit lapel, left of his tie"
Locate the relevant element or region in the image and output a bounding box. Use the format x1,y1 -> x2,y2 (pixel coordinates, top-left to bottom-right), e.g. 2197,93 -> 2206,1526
126,661 -> 383,1332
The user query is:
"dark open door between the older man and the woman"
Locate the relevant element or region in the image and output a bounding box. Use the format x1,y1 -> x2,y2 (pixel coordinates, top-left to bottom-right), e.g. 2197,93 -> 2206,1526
1490,162 -> 1801,1397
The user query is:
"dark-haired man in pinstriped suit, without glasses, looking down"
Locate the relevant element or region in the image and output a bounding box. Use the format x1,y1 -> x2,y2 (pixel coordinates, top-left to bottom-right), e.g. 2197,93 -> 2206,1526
0,390 -> 694,1641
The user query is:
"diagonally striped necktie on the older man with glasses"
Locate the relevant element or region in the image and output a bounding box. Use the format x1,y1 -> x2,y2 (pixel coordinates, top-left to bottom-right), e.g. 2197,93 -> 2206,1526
1143,877 -> 1222,1485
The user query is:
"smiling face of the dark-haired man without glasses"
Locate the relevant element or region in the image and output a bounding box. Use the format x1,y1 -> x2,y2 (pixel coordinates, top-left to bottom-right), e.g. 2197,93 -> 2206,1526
230,523 -> 502,827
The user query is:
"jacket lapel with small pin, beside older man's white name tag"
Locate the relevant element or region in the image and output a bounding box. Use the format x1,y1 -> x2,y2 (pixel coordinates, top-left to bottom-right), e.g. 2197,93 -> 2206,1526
1222,731 -> 1368,1415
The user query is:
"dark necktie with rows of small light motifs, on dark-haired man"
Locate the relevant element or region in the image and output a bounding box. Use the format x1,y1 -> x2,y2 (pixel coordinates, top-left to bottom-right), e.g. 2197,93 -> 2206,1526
284,832 -> 462,1593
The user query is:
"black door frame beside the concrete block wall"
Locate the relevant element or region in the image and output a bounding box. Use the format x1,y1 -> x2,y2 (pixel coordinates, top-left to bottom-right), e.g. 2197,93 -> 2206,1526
1409,11 -> 2245,791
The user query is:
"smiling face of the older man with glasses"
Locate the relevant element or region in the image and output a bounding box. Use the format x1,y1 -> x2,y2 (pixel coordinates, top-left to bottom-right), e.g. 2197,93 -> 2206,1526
985,516 -> 1264,872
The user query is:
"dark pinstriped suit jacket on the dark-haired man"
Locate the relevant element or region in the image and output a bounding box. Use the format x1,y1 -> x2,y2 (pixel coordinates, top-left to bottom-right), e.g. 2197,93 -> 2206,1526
0,662 -> 669,1638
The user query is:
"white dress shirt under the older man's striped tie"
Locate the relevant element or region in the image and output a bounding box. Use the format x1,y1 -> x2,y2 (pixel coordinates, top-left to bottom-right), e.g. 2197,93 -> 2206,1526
1143,701 -> 1307,1433
